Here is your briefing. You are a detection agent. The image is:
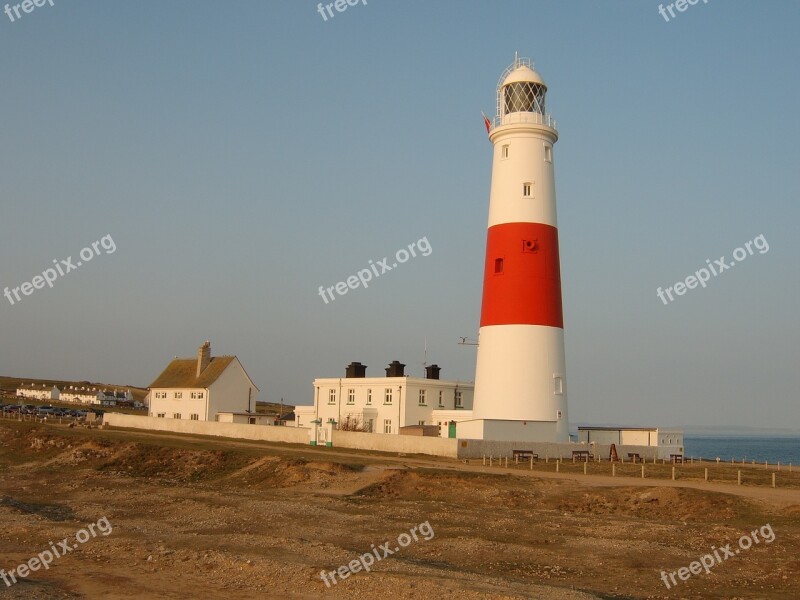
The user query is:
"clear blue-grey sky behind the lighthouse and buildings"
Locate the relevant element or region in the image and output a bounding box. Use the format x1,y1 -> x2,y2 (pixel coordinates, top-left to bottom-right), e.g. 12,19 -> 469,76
0,0 -> 800,430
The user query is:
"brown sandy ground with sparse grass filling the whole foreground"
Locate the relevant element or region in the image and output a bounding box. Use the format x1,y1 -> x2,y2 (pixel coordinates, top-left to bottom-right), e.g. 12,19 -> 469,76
0,421 -> 800,600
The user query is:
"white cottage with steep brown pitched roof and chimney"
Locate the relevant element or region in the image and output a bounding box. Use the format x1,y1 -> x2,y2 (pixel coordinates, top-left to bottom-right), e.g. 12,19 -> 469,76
149,342 -> 258,421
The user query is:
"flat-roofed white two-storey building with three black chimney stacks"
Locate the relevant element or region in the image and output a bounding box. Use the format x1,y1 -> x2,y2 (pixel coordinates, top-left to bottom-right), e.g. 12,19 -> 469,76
294,361 -> 474,437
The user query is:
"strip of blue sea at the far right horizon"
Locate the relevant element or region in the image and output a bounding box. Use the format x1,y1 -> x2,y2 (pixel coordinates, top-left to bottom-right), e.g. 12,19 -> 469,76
683,434 -> 800,466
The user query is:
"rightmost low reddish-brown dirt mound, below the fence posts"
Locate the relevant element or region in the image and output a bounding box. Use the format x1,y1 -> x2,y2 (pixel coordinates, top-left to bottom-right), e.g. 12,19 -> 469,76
546,487 -> 747,521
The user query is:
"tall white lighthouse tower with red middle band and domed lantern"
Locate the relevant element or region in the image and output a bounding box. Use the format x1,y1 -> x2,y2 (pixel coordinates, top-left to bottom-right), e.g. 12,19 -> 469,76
458,58 -> 569,442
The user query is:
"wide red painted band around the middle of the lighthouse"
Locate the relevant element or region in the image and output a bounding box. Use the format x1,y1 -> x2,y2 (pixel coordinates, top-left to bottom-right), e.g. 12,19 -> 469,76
481,223 -> 564,328
